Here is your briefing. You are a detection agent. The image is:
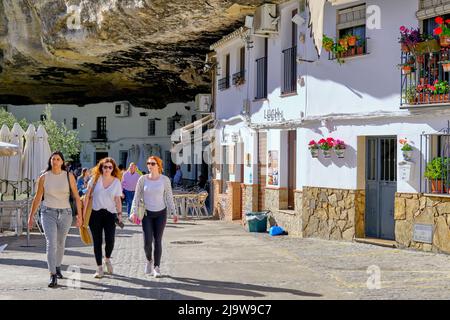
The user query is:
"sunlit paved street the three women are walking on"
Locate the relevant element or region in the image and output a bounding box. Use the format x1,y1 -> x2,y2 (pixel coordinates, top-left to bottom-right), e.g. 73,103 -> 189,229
0,220 -> 450,300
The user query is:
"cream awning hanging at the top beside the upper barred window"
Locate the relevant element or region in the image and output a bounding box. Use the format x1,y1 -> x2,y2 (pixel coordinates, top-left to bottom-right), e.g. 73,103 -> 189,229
307,0 -> 359,56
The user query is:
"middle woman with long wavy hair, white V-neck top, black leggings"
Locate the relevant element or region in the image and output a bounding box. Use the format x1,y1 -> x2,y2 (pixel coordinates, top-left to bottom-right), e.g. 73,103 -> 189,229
83,158 -> 122,278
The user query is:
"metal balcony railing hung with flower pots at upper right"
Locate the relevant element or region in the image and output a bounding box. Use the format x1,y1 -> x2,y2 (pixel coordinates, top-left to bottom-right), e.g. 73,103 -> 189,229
400,43 -> 450,105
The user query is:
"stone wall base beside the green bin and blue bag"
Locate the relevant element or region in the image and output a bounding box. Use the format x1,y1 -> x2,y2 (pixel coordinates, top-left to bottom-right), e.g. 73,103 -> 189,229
266,188 -> 303,237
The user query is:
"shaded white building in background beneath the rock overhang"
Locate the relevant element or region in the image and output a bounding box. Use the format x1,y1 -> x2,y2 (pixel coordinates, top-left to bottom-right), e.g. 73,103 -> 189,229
8,101 -> 201,180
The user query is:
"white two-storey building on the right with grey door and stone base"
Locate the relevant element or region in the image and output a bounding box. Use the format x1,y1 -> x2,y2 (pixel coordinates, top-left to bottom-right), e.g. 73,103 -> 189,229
211,0 -> 450,252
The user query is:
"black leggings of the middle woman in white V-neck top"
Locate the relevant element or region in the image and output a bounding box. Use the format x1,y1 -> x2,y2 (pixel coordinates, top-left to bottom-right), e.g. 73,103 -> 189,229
89,209 -> 116,266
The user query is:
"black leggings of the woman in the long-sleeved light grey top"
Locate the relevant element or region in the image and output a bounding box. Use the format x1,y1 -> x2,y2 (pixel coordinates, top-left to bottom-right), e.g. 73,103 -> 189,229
142,209 -> 167,267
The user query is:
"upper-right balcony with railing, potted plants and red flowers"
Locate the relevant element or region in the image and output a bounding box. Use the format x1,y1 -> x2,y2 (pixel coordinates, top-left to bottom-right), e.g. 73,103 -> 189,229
399,17 -> 450,108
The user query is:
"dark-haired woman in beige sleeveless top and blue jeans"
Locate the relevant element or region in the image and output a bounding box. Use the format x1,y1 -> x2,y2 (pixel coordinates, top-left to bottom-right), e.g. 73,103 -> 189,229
28,151 -> 82,288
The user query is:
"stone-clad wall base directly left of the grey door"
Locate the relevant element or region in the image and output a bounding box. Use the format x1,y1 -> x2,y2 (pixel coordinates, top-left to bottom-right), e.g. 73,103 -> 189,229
302,187 -> 365,241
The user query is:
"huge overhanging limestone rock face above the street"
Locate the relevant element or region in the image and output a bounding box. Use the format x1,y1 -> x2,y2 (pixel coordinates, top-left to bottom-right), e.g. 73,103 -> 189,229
0,0 -> 284,108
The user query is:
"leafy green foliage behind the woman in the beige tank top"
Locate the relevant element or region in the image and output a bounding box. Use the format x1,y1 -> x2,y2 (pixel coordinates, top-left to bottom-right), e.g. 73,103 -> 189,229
36,105 -> 81,161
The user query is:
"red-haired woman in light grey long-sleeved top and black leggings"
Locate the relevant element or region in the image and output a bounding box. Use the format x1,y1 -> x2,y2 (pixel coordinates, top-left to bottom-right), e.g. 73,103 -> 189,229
131,156 -> 178,278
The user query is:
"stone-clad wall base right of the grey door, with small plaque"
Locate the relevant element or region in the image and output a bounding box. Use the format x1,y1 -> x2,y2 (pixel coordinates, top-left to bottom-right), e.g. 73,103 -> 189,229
394,193 -> 450,253
